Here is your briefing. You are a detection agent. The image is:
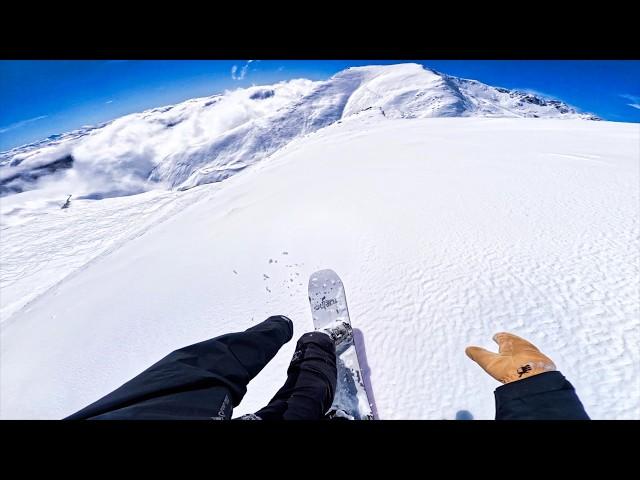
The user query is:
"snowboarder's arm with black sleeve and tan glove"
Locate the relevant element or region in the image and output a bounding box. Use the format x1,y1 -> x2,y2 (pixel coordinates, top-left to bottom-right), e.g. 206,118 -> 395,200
465,332 -> 589,420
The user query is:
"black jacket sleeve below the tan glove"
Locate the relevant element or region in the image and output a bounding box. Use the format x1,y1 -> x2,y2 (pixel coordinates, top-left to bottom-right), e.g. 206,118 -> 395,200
495,372 -> 589,420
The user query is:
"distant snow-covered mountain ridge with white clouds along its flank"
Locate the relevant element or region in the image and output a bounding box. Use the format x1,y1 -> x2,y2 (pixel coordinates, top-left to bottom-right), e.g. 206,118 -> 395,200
0,64 -> 597,199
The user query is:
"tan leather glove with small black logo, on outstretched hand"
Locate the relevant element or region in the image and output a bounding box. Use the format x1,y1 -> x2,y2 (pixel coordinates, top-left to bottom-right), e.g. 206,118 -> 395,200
465,332 -> 556,383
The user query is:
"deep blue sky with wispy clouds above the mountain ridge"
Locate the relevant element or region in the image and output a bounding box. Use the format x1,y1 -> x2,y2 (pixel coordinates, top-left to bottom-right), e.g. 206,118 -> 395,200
0,60 -> 640,151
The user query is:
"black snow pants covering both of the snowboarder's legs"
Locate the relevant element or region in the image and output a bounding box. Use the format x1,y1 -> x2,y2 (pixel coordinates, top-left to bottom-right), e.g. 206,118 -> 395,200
67,316 -> 337,420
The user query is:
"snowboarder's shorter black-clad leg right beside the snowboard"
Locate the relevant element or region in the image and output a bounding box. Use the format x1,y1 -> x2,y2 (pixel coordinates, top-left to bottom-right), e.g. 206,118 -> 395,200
249,332 -> 337,420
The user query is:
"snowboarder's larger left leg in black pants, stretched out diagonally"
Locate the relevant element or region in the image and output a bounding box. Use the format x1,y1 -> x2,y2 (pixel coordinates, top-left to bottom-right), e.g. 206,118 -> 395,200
67,316 -> 293,420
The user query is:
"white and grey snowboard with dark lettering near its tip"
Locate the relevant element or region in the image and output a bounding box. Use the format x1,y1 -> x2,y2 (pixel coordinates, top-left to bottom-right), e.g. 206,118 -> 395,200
309,270 -> 374,420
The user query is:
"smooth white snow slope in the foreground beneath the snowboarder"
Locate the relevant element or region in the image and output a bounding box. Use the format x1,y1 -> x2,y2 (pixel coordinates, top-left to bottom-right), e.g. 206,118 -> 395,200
0,115 -> 640,419
